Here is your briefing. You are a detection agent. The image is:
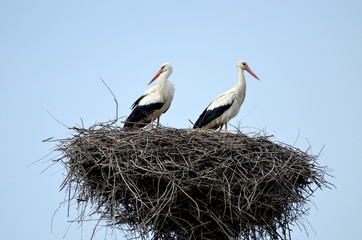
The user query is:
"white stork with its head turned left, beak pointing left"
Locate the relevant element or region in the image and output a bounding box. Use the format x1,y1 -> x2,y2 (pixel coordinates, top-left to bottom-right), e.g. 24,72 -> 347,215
124,63 -> 175,128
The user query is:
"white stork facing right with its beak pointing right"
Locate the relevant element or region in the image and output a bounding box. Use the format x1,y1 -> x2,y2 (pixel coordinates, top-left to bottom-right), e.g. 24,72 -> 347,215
194,60 -> 260,131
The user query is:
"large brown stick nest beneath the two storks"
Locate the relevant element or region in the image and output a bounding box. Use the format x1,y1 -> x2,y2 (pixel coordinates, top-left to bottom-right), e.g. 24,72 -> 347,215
51,123 -> 329,239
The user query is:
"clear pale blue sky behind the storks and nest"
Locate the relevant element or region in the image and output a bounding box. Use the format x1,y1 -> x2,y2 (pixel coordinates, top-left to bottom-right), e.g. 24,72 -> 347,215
0,0 -> 362,240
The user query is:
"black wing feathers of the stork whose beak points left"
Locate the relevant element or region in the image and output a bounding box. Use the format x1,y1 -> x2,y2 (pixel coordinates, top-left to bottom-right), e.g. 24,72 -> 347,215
124,101 -> 164,128
